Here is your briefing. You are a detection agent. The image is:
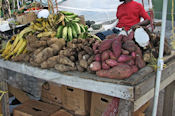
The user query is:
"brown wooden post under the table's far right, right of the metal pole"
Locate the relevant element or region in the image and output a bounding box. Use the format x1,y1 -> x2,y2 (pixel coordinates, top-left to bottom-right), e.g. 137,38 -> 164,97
163,81 -> 175,116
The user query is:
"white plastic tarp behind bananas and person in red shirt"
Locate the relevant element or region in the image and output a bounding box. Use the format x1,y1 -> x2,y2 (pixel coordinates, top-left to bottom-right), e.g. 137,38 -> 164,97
37,0 -> 151,22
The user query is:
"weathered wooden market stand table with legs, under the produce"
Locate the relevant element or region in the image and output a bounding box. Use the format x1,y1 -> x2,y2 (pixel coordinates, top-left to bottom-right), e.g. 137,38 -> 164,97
0,52 -> 175,116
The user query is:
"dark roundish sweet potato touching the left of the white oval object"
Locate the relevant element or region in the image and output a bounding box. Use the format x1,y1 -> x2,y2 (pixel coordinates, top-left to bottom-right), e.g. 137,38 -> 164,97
122,40 -> 136,52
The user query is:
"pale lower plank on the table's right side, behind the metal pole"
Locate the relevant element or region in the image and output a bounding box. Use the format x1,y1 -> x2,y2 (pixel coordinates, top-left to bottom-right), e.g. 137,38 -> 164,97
134,73 -> 175,111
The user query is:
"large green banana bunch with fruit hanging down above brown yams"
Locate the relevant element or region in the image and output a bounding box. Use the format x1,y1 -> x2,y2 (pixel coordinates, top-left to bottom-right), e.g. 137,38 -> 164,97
56,22 -> 87,41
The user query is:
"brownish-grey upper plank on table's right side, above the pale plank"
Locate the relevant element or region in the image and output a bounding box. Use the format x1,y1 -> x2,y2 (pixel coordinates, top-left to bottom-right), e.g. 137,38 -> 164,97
134,61 -> 175,100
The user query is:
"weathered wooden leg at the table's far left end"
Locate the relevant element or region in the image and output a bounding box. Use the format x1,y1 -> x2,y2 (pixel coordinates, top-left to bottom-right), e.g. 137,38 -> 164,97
0,81 -> 10,116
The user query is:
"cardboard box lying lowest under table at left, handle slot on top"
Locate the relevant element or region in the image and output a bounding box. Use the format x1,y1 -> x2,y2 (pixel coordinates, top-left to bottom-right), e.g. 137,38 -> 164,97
13,100 -> 60,116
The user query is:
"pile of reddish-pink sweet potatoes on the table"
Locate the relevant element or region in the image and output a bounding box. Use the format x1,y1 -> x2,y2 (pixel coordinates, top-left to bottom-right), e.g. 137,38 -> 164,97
90,33 -> 145,79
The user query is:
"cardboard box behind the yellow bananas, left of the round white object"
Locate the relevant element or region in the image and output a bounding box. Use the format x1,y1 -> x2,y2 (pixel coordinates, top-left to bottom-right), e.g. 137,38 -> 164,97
16,12 -> 37,25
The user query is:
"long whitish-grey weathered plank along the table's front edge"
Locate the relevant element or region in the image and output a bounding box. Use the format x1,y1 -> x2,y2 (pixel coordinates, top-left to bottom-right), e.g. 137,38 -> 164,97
0,60 -> 133,100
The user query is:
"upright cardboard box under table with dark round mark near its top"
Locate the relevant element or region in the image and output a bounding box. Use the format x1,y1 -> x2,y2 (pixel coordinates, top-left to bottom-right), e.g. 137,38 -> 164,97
41,82 -> 62,105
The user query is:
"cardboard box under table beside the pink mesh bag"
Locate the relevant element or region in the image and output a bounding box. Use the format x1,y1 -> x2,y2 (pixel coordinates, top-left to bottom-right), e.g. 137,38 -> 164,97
90,93 -> 117,116
